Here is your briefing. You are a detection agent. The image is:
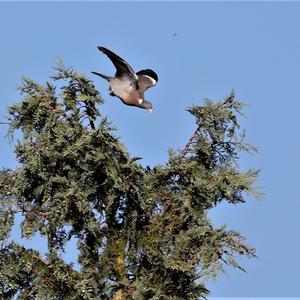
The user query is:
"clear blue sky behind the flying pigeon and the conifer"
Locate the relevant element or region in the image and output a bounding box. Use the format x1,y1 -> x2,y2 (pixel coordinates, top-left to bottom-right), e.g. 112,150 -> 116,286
0,2 -> 300,297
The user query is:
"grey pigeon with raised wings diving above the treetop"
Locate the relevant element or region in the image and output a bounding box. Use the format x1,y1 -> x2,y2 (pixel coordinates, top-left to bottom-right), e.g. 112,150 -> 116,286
92,47 -> 158,112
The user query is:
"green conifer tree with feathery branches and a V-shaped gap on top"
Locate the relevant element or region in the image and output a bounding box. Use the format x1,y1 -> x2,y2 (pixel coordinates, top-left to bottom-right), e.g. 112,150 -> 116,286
0,64 -> 258,300
